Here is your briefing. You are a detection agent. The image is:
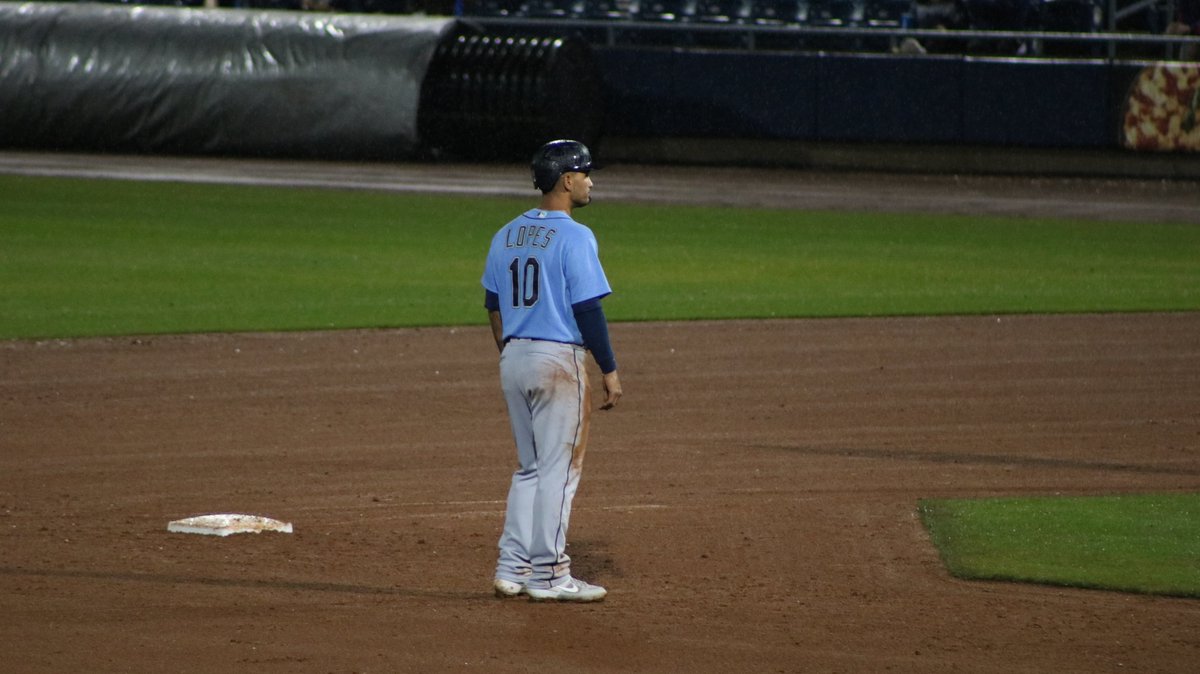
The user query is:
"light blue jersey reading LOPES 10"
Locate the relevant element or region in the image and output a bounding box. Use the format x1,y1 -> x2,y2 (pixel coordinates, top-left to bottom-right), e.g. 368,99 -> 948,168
482,209 -> 612,344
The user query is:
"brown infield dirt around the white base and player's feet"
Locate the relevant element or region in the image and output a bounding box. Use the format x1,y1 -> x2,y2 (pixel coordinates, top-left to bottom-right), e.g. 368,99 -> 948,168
0,313 -> 1200,674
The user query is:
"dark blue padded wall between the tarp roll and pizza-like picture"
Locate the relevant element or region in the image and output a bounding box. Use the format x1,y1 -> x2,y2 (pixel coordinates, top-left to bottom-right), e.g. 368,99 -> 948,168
595,47 -> 1142,148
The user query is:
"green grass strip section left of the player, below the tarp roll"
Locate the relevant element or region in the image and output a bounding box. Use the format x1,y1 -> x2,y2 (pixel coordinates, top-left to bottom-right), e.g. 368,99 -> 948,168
0,176 -> 506,337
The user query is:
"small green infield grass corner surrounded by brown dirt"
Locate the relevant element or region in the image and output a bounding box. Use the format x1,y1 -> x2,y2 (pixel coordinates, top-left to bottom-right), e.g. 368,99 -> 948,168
918,494 -> 1200,597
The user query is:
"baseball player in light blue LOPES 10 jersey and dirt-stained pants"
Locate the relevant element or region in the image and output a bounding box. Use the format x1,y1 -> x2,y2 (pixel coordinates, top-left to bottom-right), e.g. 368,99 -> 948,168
482,140 -> 622,602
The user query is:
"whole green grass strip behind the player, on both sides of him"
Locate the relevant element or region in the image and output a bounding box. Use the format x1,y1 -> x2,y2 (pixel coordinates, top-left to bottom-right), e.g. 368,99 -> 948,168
0,176 -> 1200,338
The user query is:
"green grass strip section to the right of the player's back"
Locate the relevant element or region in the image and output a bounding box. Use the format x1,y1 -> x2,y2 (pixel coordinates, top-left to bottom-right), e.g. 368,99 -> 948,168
595,199 -> 1200,319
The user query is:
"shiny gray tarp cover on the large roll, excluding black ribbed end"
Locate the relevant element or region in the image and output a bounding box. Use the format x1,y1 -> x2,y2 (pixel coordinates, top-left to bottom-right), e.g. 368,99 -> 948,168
0,1 -> 454,157
